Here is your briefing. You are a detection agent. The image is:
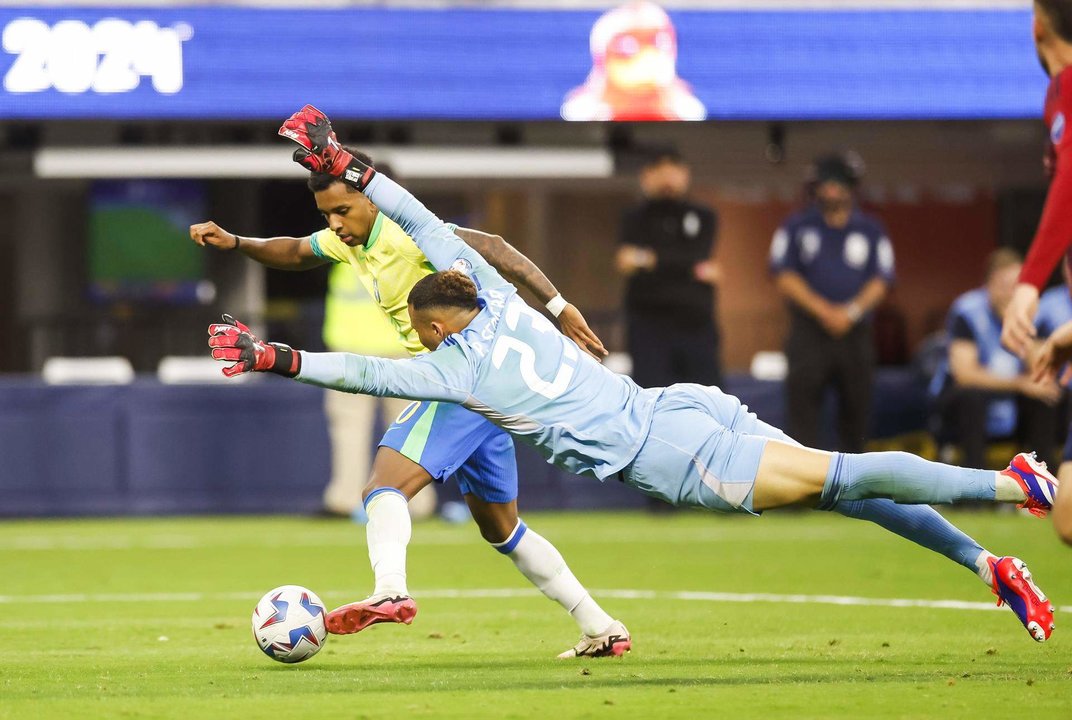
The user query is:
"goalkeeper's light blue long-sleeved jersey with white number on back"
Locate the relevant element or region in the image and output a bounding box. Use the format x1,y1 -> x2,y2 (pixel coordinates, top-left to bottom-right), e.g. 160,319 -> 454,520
297,175 -> 662,480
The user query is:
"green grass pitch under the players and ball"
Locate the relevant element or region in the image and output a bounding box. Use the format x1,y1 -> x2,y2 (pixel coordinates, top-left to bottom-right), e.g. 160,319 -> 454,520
0,512 -> 1072,720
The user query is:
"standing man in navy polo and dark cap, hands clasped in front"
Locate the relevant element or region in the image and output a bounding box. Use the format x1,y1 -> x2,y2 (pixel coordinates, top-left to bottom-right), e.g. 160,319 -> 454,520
771,154 -> 893,452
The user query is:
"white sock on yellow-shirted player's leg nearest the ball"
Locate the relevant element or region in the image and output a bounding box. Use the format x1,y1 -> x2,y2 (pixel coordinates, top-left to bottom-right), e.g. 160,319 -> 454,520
364,488 -> 413,595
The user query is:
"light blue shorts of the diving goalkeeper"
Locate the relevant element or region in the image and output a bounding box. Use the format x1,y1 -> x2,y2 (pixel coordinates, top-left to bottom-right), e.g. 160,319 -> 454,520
622,384 -> 796,514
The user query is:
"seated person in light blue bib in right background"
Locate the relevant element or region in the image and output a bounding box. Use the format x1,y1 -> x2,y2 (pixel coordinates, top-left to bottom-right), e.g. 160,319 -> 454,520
932,248 -> 1068,467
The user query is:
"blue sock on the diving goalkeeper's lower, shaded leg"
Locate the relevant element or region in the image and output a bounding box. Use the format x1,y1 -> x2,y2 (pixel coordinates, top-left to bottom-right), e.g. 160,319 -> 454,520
834,498 -> 985,574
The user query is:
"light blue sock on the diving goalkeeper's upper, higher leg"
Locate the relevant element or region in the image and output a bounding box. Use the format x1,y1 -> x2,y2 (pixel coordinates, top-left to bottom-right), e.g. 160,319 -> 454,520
819,452 -> 995,510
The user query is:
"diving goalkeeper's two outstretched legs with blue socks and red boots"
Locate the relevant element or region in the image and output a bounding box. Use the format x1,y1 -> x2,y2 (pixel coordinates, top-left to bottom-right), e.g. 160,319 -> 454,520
753,443 -> 1058,642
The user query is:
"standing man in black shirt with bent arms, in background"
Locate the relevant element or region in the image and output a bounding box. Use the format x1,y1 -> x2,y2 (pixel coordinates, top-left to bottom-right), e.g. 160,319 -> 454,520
615,148 -> 721,387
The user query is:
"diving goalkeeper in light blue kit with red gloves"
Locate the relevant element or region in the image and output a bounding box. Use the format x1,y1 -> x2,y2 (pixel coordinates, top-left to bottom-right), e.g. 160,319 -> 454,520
209,117 -> 1057,642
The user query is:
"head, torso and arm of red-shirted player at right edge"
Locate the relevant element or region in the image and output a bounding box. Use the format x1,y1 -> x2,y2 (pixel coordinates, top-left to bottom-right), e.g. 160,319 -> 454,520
1001,0 -> 1072,356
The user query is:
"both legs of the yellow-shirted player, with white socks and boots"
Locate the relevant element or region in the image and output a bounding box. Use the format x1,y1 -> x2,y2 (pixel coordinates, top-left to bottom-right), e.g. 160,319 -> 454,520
326,448 -> 631,657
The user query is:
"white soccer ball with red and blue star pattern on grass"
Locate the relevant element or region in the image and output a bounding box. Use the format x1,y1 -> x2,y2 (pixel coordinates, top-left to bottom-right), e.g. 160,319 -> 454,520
253,585 -> 328,662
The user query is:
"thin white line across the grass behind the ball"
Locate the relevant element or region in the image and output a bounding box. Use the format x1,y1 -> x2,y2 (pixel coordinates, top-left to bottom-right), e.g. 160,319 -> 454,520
0,588 -> 1072,613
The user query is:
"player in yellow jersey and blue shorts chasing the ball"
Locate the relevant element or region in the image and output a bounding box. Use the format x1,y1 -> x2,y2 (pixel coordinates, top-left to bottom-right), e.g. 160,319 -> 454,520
190,150 -> 631,658
